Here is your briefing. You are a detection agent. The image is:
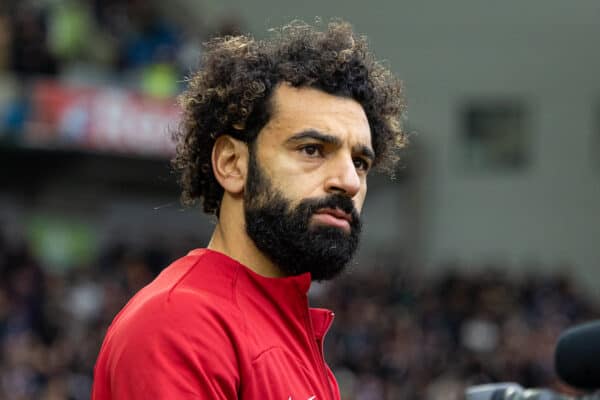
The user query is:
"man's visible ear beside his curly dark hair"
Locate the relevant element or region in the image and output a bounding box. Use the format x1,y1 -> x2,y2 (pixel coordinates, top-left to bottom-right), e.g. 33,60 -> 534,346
211,135 -> 248,195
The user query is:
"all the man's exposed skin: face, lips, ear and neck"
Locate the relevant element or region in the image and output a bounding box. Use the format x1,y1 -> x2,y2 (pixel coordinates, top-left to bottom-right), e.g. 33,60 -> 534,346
208,84 -> 375,276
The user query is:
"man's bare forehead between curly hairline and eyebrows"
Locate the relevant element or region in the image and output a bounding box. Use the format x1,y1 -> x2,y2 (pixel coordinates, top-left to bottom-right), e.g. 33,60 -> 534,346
267,84 -> 371,147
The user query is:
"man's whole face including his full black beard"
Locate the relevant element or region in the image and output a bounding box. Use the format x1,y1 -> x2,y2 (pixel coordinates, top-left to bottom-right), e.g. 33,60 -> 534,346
244,85 -> 374,280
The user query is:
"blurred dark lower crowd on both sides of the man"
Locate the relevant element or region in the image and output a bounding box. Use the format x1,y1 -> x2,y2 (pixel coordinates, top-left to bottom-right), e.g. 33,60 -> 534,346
0,223 -> 600,400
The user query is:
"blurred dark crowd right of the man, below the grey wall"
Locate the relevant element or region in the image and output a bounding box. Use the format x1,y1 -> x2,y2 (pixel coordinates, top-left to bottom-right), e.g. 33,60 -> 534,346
315,265 -> 600,400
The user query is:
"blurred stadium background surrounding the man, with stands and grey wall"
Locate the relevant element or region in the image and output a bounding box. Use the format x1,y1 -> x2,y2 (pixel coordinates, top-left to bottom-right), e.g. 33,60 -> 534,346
0,0 -> 600,400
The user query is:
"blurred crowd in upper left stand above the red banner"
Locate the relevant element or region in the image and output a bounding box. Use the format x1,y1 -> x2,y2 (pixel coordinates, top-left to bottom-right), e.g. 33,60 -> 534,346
0,0 -> 240,97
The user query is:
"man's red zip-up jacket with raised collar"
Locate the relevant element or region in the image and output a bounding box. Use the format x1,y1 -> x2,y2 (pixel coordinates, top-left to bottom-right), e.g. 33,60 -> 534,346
92,249 -> 340,400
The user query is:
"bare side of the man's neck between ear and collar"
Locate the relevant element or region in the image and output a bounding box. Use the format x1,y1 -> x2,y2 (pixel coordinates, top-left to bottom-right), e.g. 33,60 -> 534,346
207,195 -> 285,278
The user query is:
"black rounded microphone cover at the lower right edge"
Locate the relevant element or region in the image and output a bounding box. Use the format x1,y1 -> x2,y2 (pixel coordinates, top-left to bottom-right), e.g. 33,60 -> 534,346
554,321 -> 600,391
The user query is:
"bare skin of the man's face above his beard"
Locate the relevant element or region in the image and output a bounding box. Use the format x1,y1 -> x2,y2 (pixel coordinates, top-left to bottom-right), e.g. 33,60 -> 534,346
251,85 -> 373,223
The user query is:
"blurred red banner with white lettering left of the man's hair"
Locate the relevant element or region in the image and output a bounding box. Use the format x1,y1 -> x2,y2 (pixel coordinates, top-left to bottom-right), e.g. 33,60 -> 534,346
26,82 -> 179,156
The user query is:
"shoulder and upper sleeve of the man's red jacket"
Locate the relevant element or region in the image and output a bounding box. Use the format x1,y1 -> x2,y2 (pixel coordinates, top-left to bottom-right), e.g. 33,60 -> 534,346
96,253 -> 245,398
